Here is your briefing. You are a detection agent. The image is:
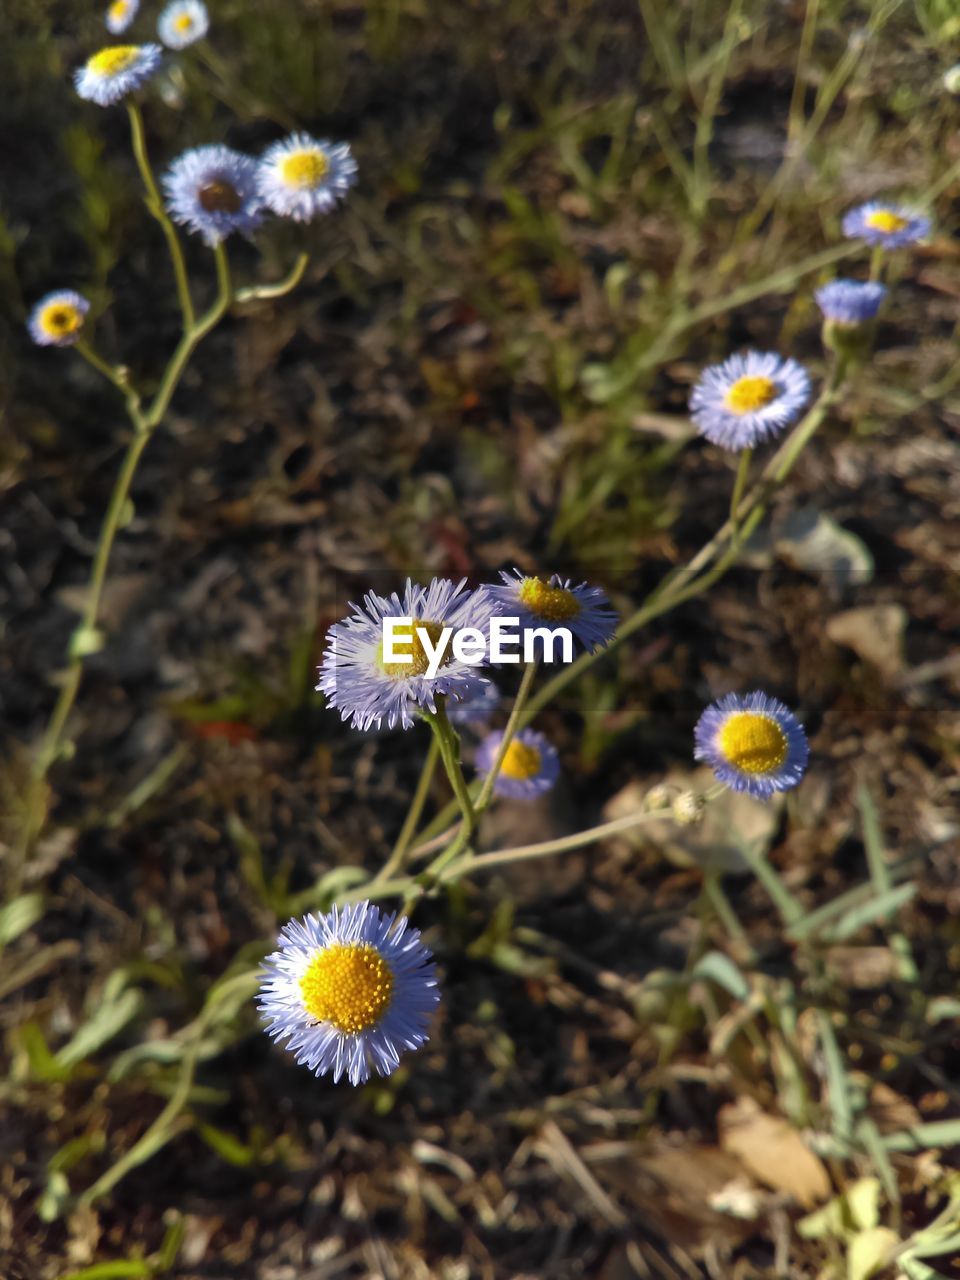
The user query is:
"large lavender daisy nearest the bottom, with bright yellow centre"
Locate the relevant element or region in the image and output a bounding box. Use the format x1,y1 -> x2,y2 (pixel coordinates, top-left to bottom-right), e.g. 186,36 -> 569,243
259,902 -> 440,1084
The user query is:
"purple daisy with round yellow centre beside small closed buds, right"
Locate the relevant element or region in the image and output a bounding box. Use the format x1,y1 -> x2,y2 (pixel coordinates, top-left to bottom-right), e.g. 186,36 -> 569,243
694,691 -> 810,799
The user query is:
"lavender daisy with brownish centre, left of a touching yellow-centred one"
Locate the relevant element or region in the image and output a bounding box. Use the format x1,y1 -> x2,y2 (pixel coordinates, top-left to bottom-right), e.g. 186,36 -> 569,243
164,146 -> 264,244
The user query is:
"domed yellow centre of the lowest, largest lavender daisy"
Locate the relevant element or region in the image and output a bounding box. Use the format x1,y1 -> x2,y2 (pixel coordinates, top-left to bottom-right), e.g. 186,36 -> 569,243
300,942 -> 393,1036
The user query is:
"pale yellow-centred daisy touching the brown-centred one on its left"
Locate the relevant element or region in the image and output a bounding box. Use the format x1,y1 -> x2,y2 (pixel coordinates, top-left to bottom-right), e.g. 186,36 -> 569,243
257,133 -> 357,223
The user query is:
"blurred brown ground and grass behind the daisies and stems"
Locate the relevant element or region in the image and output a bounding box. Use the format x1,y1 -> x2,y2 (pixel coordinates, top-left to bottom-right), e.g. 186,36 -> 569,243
0,0 -> 960,1280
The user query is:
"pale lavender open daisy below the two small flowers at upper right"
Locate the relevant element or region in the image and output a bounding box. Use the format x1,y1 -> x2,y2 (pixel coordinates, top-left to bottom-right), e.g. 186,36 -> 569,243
690,351 -> 810,449
